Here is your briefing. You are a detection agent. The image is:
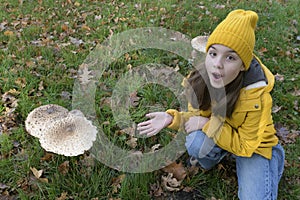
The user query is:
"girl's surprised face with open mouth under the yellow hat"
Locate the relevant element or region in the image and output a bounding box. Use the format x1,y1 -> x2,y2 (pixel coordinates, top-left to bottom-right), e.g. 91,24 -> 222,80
205,44 -> 244,88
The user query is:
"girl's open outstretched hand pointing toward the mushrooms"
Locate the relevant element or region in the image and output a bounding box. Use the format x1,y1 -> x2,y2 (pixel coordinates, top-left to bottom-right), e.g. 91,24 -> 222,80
137,112 -> 173,136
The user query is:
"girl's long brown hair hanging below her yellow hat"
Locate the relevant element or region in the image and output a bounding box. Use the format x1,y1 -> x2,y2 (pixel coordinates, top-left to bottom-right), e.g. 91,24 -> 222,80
186,64 -> 244,117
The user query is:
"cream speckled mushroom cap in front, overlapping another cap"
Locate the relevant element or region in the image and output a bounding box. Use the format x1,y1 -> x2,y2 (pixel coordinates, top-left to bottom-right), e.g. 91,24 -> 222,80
40,112 -> 97,156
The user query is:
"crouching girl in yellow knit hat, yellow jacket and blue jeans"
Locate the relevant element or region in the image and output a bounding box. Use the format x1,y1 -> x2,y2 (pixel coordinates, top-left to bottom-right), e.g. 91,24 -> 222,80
138,9 -> 284,200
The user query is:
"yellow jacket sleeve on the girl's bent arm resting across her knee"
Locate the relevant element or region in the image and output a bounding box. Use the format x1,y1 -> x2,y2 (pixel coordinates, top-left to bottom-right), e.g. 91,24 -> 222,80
202,93 -> 272,157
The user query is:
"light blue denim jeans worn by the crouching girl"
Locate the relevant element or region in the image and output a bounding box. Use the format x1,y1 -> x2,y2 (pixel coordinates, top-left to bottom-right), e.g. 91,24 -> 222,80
185,131 -> 284,200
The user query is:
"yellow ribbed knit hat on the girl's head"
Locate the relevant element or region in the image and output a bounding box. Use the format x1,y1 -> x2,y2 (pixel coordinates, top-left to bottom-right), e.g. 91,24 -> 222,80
206,9 -> 258,70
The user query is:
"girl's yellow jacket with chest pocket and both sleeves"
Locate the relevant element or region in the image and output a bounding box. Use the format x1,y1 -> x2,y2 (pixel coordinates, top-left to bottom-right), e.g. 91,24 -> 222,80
166,56 -> 278,159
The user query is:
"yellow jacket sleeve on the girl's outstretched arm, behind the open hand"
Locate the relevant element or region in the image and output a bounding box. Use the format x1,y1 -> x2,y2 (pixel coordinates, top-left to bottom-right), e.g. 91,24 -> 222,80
166,104 -> 211,130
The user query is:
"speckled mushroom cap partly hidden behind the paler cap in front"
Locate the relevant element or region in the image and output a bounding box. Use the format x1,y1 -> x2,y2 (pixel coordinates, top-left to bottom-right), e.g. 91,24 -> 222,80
25,104 -> 69,138
